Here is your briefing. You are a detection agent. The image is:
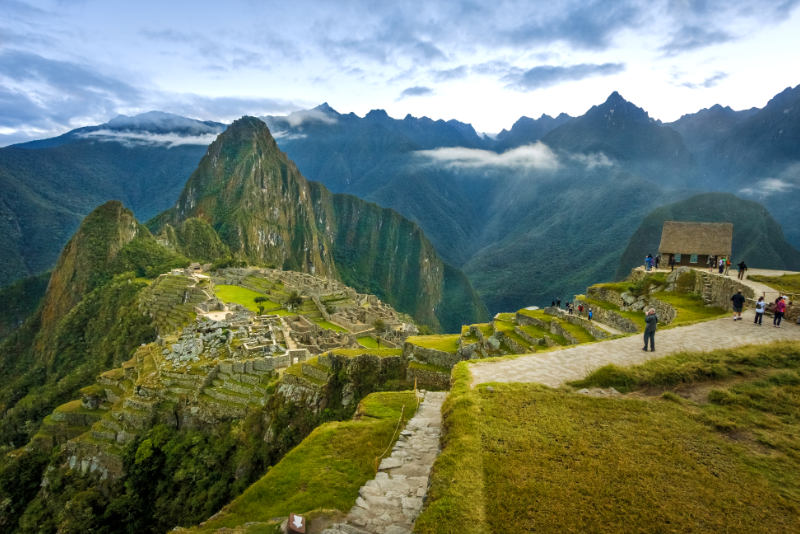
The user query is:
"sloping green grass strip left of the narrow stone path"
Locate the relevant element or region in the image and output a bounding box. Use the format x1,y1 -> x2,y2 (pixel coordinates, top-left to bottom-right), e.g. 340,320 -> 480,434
197,391 -> 417,532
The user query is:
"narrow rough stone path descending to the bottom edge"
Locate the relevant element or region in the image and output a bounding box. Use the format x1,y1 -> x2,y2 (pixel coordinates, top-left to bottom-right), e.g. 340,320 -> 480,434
323,391 -> 447,534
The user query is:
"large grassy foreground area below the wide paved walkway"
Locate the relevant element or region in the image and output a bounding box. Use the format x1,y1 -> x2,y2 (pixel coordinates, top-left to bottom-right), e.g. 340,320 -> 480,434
415,343 -> 800,533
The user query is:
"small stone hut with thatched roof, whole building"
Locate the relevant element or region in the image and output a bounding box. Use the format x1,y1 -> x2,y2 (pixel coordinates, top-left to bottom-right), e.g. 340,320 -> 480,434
658,221 -> 733,267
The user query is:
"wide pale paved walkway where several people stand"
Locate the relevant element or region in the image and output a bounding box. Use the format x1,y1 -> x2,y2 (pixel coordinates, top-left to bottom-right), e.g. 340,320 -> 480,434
470,311 -> 800,387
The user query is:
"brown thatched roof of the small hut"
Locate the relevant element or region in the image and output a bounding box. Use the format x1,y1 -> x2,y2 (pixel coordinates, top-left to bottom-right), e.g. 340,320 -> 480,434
658,221 -> 733,256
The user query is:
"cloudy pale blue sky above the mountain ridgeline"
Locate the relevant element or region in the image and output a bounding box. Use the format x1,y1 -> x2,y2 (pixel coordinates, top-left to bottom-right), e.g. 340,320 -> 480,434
0,0 -> 800,146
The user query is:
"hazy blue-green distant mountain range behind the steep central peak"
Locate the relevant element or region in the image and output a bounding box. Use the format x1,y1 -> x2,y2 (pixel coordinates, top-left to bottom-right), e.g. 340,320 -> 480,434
0,87 -> 800,312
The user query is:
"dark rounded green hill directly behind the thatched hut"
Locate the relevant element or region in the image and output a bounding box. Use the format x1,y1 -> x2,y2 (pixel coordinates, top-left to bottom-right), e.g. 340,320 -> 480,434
616,193 -> 800,279
